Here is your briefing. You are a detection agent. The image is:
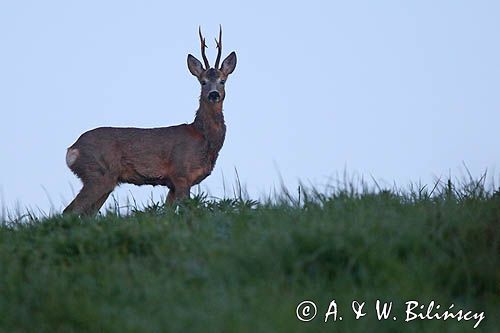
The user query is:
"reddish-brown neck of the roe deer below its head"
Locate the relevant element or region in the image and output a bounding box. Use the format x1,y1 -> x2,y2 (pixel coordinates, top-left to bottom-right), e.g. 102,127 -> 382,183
193,100 -> 226,154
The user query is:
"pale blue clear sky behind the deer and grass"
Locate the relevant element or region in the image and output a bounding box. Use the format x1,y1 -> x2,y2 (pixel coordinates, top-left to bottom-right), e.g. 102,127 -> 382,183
0,1 -> 500,210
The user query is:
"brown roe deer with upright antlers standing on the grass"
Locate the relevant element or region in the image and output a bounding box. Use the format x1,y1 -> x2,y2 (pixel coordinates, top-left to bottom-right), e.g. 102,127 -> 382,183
63,28 -> 236,215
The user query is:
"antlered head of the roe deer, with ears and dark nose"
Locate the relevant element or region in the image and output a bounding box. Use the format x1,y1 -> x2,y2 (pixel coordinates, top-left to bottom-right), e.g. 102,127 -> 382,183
187,27 -> 236,103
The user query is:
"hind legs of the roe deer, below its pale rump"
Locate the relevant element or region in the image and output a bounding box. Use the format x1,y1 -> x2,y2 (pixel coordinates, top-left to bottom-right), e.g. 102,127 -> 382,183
63,180 -> 115,216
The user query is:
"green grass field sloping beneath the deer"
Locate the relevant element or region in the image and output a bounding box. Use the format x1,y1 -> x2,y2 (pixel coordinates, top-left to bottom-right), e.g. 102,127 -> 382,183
0,181 -> 500,333
